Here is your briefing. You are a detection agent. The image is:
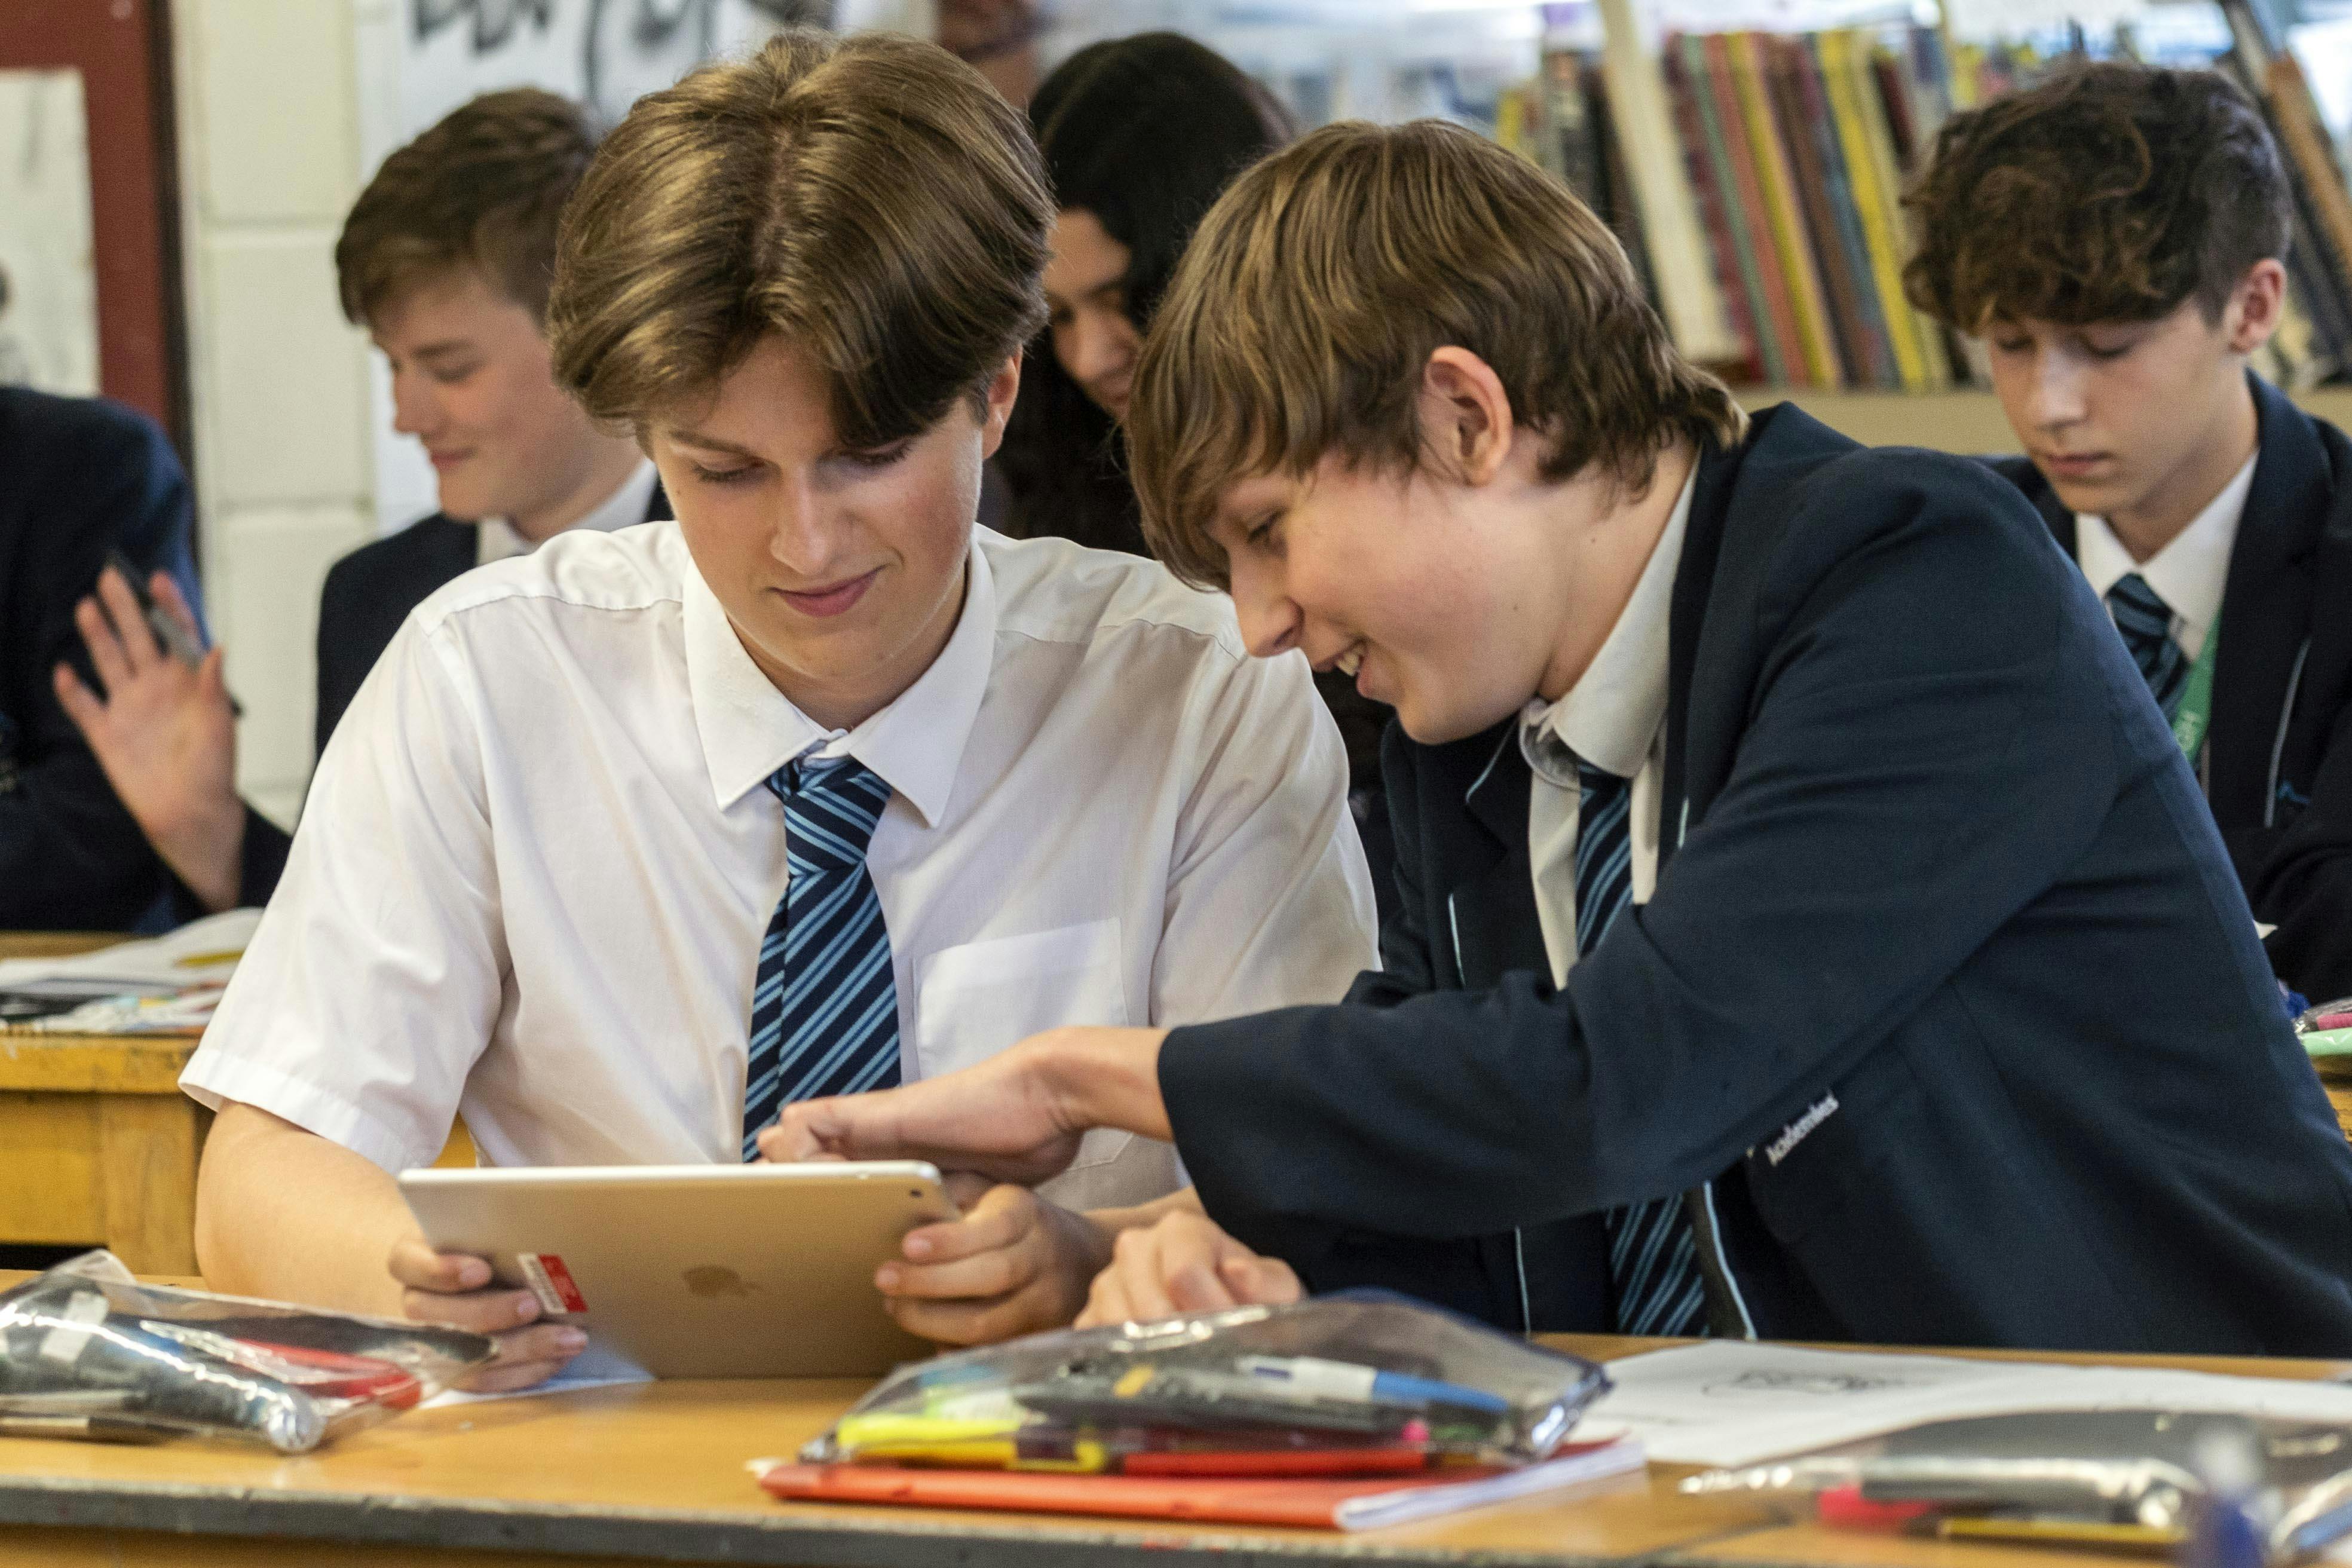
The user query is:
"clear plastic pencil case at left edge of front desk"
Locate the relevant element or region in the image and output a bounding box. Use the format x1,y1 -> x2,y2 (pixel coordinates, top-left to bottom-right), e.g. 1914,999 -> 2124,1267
0,1253 -> 496,1453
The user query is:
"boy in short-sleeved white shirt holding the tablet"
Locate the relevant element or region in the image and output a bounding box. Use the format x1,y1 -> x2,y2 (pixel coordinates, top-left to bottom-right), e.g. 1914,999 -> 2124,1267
183,33 -> 1371,1385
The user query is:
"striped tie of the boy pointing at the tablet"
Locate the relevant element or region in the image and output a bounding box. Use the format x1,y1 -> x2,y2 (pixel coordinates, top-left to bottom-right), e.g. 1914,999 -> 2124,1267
1576,757 -> 1708,1333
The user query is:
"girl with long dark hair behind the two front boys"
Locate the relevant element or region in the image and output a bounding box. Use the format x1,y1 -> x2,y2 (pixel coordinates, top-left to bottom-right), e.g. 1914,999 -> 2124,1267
995,33 -> 1395,917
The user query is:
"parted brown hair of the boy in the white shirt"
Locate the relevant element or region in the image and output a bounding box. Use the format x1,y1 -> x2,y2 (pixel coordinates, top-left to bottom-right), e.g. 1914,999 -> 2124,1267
548,30 -> 1054,451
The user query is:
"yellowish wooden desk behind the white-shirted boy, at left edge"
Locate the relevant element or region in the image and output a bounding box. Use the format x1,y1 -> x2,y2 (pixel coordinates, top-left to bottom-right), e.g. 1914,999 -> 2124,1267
0,933 -> 212,1274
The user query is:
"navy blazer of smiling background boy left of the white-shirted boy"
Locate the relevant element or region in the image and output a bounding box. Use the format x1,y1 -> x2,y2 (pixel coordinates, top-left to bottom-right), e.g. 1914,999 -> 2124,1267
238,482 -> 670,905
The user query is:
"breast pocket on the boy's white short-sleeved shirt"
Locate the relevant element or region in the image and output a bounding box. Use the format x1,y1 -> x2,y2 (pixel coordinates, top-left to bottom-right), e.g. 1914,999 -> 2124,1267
915,917 -> 1134,1171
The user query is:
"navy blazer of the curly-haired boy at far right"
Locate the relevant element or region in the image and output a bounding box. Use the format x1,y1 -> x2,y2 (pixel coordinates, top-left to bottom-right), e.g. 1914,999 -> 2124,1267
1995,374 -> 2352,1002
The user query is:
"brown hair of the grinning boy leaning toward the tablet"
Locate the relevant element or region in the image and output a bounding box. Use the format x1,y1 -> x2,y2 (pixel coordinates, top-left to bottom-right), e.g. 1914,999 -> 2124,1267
1126,120 -> 1743,586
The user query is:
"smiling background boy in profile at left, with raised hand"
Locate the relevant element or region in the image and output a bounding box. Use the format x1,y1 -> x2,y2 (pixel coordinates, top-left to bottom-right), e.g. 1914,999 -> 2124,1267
56,87 -> 670,919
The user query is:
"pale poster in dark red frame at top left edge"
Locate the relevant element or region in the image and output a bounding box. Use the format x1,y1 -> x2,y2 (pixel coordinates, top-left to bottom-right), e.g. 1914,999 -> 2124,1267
0,71 -> 99,397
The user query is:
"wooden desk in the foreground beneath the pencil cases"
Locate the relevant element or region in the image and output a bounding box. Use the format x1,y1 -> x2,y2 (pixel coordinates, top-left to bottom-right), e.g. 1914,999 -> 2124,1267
0,1325 -> 2340,1568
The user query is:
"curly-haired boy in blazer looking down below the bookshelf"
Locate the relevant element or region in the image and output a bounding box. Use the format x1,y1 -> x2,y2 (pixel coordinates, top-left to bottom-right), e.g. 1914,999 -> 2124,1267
1905,63 -> 2352,1002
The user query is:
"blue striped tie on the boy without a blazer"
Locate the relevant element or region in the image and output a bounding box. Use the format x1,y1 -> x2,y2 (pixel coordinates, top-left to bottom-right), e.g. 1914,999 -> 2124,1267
743,757 -> 899,1161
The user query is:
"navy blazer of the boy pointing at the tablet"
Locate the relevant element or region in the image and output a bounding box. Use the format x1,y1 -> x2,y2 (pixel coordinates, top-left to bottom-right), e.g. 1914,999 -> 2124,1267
1159,407 -> 2352,1354
